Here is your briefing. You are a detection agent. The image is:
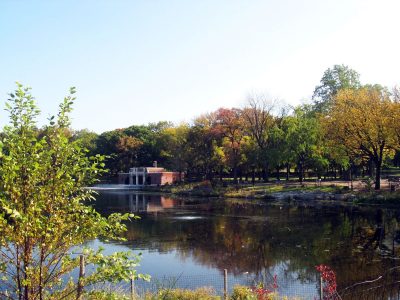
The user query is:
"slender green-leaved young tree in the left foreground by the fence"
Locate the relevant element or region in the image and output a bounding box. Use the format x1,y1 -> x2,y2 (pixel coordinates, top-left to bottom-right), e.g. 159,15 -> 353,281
0,84 -> 148,300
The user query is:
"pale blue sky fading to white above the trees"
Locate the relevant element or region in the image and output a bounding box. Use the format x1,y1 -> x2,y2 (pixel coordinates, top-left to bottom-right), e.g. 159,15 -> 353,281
0,0 -> 400,133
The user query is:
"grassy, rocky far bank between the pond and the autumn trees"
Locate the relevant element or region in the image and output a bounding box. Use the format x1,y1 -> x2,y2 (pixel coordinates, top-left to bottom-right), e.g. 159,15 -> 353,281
145,181 -> 400,206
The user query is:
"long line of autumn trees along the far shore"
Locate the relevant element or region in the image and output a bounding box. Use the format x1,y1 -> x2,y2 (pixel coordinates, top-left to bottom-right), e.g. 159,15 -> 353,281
73,65 -> 400,189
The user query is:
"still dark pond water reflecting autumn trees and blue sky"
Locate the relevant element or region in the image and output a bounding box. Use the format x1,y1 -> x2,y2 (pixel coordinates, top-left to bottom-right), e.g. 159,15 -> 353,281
93,191 -> 400,299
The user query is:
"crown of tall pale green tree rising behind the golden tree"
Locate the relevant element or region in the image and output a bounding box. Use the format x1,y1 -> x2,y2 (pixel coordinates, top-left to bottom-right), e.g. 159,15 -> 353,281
313,65 -> 361,112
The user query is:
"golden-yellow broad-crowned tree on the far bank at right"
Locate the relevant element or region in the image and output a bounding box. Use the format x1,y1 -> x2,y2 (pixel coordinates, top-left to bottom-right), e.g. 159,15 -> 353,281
324,87 -> 399,190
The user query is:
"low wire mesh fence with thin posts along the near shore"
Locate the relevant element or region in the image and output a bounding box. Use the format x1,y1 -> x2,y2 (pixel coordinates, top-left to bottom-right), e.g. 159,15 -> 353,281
73,255 -> 400,300
